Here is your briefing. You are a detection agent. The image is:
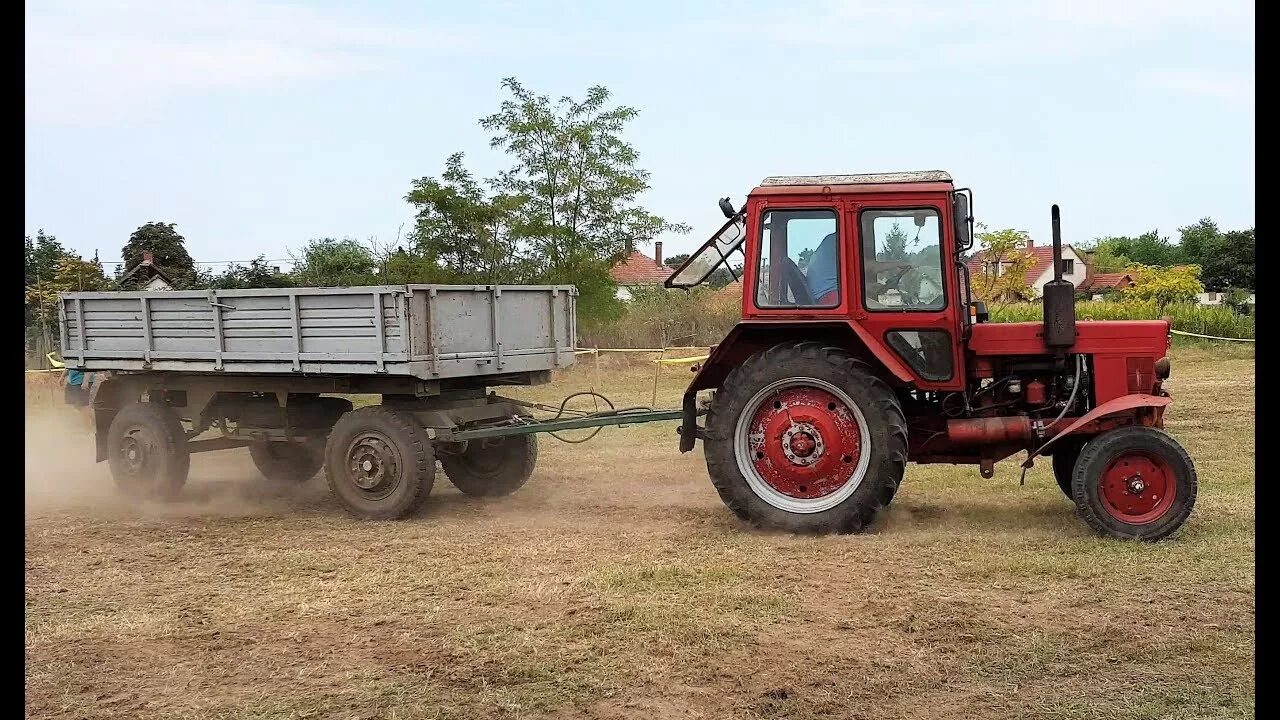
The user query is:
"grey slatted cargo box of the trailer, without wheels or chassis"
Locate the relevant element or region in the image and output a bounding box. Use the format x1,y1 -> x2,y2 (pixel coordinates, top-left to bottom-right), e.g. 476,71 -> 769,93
58,284 -> 577,380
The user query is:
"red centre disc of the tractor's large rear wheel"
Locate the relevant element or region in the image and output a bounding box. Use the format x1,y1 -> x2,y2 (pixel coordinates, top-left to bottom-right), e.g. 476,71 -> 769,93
749,386 -> 863,500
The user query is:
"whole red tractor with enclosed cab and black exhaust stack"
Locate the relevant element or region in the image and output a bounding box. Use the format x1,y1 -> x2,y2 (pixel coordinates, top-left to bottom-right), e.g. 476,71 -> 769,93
667,172 -> 1197,541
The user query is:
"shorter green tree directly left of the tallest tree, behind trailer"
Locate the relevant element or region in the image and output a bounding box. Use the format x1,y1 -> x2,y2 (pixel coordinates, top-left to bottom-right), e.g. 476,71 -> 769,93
409,152 -> 527,283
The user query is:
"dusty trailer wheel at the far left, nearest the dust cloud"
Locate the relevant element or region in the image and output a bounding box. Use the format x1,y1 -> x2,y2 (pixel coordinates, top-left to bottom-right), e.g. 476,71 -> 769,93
106,402 -> 191,500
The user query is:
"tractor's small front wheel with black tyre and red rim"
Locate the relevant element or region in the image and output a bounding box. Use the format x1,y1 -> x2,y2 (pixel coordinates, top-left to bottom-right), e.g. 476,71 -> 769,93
1071,427 -> 1198,541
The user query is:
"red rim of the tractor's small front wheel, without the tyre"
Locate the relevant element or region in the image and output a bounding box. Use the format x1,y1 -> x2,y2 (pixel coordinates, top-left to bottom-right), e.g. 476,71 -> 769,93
1098,451 -> 1178,525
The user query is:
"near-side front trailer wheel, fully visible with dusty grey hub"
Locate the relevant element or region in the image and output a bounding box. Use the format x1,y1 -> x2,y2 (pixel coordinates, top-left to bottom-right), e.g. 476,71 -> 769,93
324,406 -> 435,520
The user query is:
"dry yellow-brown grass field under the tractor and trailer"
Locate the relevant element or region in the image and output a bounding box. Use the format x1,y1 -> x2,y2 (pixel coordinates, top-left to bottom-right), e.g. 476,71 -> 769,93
26,346 -> 1254,720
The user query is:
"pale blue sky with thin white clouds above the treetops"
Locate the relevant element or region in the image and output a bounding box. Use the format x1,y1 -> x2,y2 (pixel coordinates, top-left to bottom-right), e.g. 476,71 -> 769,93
26,0 -> 1254,270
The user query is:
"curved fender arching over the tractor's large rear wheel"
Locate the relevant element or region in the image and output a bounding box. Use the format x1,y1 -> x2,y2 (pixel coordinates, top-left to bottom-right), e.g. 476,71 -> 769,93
680,320 -> 914,452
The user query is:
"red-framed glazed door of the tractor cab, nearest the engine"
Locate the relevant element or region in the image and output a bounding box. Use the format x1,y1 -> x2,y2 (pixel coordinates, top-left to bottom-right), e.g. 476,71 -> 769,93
845,196 -> 964,391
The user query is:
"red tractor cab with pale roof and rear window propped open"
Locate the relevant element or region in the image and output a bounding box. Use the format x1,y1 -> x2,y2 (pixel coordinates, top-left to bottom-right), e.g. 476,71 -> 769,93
666,170 -> 973,389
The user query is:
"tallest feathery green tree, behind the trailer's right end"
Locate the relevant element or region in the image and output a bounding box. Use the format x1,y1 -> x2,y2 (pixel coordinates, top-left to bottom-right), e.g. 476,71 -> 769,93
480,78 -> 689,320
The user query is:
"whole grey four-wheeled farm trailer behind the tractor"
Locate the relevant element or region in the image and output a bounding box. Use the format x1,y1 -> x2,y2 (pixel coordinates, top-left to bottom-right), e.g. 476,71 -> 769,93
58,284 -> 577,519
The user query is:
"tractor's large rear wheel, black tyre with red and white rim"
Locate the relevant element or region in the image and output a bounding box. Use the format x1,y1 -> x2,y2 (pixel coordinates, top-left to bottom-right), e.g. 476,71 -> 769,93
705,342 -> 906,533
